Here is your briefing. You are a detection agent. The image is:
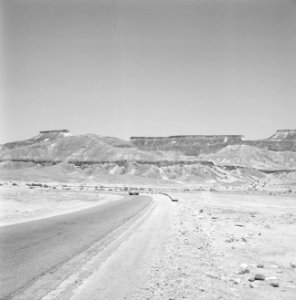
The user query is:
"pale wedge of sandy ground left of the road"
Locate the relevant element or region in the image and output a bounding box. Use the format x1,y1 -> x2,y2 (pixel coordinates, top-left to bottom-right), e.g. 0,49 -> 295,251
0,185 -> 123,227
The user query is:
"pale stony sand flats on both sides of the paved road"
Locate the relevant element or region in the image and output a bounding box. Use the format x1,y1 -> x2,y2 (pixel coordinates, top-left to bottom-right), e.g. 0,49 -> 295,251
1,188 -> 296,300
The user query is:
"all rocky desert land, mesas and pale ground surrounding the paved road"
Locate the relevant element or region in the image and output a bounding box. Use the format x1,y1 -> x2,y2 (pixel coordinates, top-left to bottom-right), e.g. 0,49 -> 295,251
0,130 -> 296,300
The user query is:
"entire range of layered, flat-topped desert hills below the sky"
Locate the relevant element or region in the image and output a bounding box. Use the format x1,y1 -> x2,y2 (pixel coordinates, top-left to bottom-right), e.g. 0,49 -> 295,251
0,130 -> 296,185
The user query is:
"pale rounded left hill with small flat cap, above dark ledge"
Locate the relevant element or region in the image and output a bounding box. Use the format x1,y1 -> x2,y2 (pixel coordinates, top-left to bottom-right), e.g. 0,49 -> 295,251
0,130 -> 192,163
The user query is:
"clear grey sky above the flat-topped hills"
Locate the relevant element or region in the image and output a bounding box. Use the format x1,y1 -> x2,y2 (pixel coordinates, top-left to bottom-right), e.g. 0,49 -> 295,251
0,0 -> 296,143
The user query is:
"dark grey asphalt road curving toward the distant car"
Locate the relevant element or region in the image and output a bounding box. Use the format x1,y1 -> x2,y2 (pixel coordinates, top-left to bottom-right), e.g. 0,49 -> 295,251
0,196 -> 151,299
